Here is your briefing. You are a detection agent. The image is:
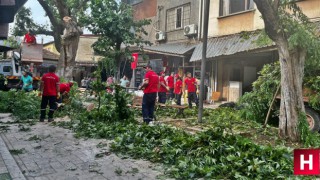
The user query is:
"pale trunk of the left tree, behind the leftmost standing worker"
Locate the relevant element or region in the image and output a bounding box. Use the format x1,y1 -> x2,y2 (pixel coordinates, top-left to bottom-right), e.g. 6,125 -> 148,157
58,19 -> 82,81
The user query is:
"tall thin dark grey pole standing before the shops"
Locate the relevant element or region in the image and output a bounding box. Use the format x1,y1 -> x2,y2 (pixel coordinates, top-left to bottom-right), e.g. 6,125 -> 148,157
198,0 -> 210,123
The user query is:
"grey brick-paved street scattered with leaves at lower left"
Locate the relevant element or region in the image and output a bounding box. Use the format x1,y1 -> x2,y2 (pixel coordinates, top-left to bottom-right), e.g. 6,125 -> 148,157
0,114 -> 163,180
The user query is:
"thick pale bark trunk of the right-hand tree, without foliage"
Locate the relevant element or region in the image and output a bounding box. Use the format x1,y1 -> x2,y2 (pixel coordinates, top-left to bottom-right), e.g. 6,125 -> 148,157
254,0 -> 306,142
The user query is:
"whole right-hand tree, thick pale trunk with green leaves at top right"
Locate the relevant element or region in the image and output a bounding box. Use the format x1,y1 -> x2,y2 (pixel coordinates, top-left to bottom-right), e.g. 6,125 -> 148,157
254,0 -> 320,141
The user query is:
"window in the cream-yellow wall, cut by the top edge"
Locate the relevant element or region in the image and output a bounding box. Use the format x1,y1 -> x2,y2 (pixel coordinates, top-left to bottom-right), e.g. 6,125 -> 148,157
219,0 -> 253,16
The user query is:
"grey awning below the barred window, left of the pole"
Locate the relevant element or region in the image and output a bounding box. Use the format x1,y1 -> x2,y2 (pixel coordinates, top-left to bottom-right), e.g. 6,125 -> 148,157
143,43 -> 197,57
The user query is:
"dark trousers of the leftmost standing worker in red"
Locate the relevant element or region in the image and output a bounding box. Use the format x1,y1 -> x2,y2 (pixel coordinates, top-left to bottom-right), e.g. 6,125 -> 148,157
40,96 -> 57,120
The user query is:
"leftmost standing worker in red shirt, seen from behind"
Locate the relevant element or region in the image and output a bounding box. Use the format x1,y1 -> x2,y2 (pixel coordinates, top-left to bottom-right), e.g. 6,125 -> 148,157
39,65 -> 60,122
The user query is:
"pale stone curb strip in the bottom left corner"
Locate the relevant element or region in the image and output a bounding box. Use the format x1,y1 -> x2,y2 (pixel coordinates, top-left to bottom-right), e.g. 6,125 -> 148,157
0,133 -> 26,180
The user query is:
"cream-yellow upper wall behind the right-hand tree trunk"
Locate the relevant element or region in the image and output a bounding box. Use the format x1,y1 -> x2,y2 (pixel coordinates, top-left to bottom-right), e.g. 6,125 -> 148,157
208,0 -> 320,37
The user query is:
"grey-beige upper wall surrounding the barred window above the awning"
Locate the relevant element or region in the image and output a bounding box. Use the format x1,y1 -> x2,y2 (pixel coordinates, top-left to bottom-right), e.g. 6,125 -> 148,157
157,0 -> 199,43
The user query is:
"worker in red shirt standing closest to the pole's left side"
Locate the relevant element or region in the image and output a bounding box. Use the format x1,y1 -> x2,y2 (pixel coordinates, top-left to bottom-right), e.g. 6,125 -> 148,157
184,72 -> 198,108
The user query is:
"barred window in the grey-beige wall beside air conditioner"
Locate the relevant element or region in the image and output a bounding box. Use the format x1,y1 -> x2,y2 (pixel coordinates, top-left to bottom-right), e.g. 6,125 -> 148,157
166,4 -> 191,31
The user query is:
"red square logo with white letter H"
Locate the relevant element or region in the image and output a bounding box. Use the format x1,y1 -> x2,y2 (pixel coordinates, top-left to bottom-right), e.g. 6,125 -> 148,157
293,149 -> 320,175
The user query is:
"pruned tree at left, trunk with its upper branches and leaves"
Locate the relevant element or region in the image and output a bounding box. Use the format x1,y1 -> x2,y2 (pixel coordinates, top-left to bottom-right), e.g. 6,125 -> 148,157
14,0 -> 89,80
